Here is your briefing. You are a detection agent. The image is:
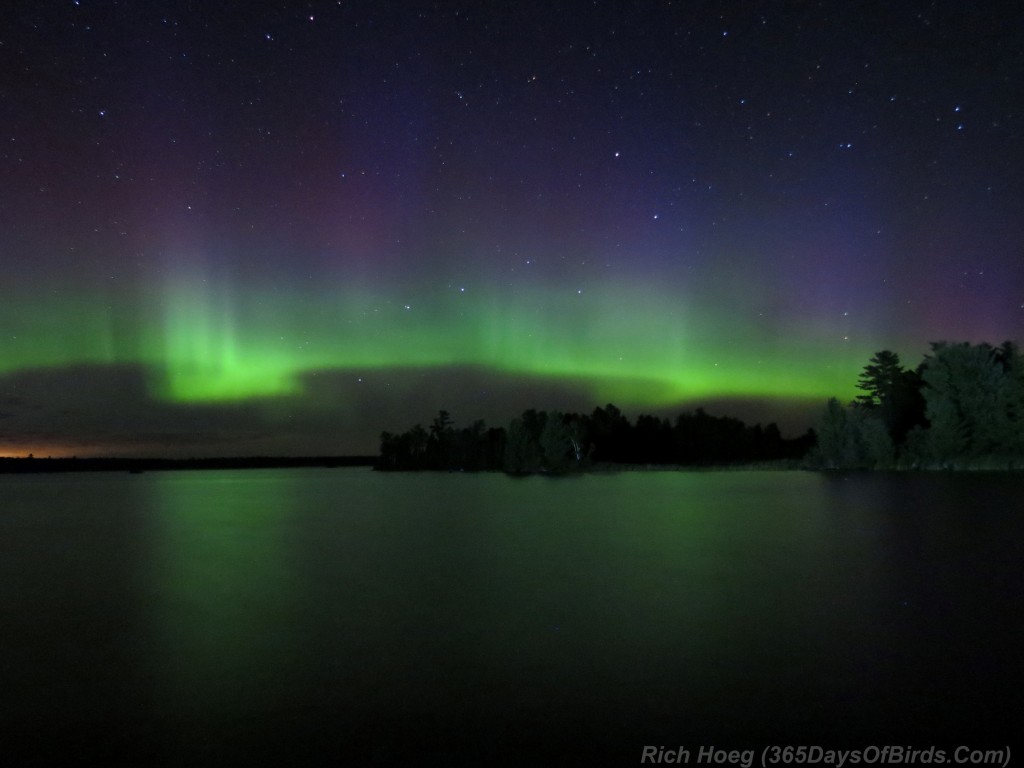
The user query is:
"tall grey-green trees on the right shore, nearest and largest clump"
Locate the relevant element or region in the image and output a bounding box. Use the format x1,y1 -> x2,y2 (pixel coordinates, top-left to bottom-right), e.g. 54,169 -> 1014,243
810,341 -> 1024,469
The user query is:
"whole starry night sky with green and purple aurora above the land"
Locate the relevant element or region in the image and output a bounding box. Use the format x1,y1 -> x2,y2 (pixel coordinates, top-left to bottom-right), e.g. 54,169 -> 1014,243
0,0 -> 1024,456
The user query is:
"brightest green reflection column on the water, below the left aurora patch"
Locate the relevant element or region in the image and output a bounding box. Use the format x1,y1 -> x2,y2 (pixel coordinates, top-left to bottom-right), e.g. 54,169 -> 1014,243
150,471 -> 301,717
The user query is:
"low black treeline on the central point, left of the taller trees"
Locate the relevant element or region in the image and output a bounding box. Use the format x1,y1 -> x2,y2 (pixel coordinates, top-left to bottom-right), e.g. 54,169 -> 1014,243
376,404 -> 814,474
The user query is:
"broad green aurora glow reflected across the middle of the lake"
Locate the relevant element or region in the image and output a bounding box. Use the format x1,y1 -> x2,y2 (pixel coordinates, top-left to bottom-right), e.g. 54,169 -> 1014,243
132,470 -> 885,759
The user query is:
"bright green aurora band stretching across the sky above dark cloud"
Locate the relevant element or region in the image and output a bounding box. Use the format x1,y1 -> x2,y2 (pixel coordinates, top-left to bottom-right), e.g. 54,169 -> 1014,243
0,270 -> 876,407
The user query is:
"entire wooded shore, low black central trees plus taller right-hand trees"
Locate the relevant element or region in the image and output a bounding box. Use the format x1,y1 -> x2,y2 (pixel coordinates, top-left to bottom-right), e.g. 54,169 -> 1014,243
375,341 -> 1024,475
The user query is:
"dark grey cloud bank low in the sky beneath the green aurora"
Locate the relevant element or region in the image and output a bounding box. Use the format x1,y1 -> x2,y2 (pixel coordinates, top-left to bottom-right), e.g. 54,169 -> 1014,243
0,366 -> 820,458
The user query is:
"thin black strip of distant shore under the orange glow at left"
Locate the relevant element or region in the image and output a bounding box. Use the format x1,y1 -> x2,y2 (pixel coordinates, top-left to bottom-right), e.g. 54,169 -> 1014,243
0,456 -> 377,474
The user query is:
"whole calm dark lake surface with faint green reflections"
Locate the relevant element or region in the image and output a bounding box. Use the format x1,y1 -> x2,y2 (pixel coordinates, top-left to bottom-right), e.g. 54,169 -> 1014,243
0,469 -> 1024,766
